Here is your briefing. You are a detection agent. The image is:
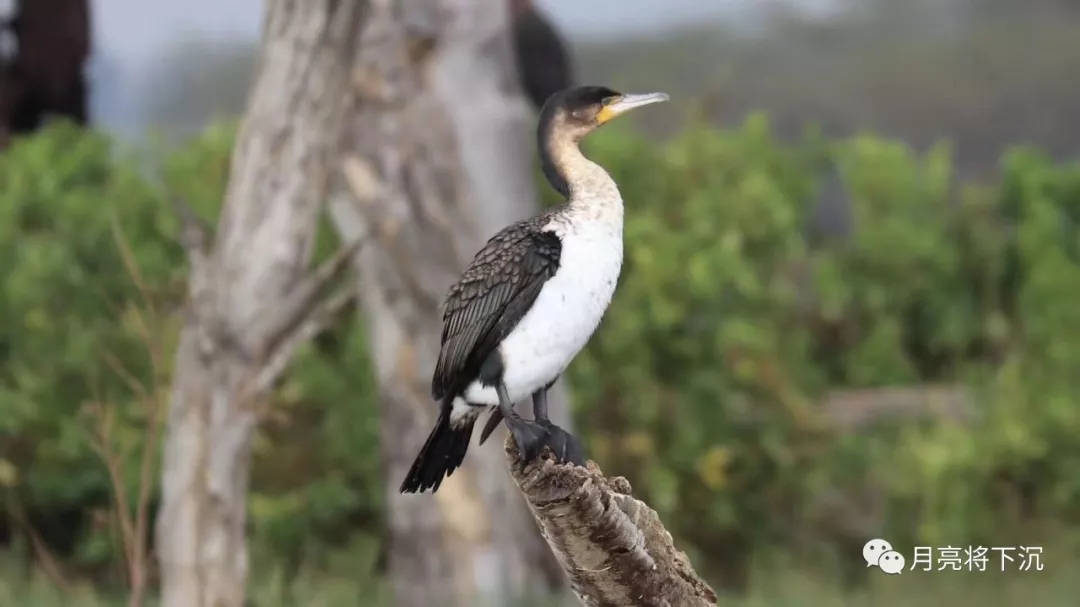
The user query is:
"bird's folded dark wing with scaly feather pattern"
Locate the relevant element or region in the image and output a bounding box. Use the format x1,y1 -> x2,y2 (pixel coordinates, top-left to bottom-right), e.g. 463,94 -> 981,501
431,220 -> 563,400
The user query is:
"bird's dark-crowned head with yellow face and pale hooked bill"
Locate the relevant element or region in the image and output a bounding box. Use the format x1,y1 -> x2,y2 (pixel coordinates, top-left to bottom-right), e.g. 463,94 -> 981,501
540,86 -> 669,140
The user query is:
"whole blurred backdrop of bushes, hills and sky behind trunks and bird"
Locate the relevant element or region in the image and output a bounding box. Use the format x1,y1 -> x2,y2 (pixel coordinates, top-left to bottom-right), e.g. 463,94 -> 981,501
0,0 -> 1080,607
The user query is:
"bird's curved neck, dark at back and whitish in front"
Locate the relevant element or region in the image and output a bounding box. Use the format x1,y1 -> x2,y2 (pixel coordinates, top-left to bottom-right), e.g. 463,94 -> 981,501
540,130 -> 622,215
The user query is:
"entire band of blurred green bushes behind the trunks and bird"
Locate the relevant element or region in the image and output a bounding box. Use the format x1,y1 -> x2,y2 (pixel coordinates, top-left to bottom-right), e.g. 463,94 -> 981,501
0,116 -> 1080,592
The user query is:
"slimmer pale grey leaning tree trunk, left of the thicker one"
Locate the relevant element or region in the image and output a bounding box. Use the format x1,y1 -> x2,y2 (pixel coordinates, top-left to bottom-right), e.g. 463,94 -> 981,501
157,0 -> 364,607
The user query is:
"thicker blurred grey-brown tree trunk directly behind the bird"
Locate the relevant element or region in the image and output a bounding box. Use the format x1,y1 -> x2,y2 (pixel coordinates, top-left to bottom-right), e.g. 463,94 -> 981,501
330,0 -> 567,607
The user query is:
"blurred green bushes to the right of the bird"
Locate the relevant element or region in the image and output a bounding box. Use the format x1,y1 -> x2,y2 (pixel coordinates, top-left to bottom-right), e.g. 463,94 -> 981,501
571,116 -> 1080,561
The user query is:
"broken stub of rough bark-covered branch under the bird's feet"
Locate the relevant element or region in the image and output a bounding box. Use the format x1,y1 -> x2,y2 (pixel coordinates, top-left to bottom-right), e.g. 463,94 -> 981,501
504,435 -> 716,607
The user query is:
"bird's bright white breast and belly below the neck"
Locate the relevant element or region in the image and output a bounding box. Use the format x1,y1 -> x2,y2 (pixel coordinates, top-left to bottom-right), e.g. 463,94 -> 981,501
456,217 -> 622,406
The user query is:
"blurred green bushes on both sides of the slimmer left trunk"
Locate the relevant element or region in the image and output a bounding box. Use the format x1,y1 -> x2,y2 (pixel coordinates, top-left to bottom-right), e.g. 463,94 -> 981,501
0,119 -> 380,587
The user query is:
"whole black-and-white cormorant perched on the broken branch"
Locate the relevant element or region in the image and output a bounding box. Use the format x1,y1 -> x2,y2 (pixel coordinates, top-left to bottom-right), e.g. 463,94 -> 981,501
401,86 -> 667,493
